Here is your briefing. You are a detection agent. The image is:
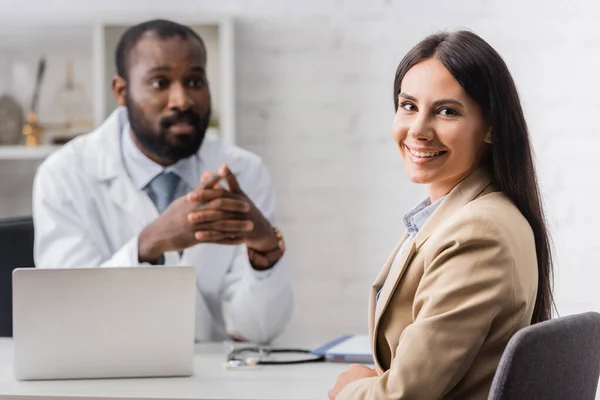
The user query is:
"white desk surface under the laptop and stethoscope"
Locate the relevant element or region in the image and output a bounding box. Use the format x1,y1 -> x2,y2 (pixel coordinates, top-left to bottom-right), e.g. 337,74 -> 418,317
0,338 -> 347,400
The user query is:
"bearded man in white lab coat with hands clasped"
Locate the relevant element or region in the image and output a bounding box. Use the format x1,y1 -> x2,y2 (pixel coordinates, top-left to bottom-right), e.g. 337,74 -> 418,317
33,20 -> 292,342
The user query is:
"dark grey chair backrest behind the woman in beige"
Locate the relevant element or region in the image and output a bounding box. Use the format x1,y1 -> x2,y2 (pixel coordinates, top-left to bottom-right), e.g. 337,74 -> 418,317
488,312 -> 600,400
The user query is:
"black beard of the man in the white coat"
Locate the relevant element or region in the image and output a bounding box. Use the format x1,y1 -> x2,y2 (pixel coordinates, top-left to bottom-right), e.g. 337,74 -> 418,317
125,95 -> 211,163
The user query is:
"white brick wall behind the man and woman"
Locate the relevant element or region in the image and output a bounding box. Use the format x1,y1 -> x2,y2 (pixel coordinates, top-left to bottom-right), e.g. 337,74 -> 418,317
0,0 -> 600,348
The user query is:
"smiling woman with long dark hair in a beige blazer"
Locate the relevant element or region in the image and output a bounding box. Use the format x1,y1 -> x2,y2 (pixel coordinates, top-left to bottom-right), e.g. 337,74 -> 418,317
329,31 -> 553,399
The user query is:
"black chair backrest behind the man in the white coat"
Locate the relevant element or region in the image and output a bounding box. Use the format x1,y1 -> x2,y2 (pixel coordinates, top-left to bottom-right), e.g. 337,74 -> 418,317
0,217 -> 34,336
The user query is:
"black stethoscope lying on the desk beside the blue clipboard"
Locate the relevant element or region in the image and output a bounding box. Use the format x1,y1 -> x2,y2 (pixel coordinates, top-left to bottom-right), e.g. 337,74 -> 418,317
224,347 -> 325,370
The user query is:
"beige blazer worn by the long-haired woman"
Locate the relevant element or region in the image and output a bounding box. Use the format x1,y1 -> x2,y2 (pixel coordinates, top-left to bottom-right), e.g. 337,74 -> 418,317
338,169 -> 538,400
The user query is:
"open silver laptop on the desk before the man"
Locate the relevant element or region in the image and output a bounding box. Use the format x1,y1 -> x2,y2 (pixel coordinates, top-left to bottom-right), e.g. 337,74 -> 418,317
13,267 -> 196,380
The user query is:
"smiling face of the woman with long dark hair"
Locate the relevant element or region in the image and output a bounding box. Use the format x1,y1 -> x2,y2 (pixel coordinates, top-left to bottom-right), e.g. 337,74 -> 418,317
392,58 -> 492,201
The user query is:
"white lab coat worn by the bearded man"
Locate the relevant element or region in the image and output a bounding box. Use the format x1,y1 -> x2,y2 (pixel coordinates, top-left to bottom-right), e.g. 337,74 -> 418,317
33,108 -> 293,342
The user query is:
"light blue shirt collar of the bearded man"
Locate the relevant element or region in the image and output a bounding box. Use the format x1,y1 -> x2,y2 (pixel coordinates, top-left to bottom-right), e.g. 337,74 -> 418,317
121,122 -> 200,190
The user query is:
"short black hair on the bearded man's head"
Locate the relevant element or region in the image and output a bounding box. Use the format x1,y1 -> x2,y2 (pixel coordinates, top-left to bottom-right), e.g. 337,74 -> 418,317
115,19 -> 206,80
